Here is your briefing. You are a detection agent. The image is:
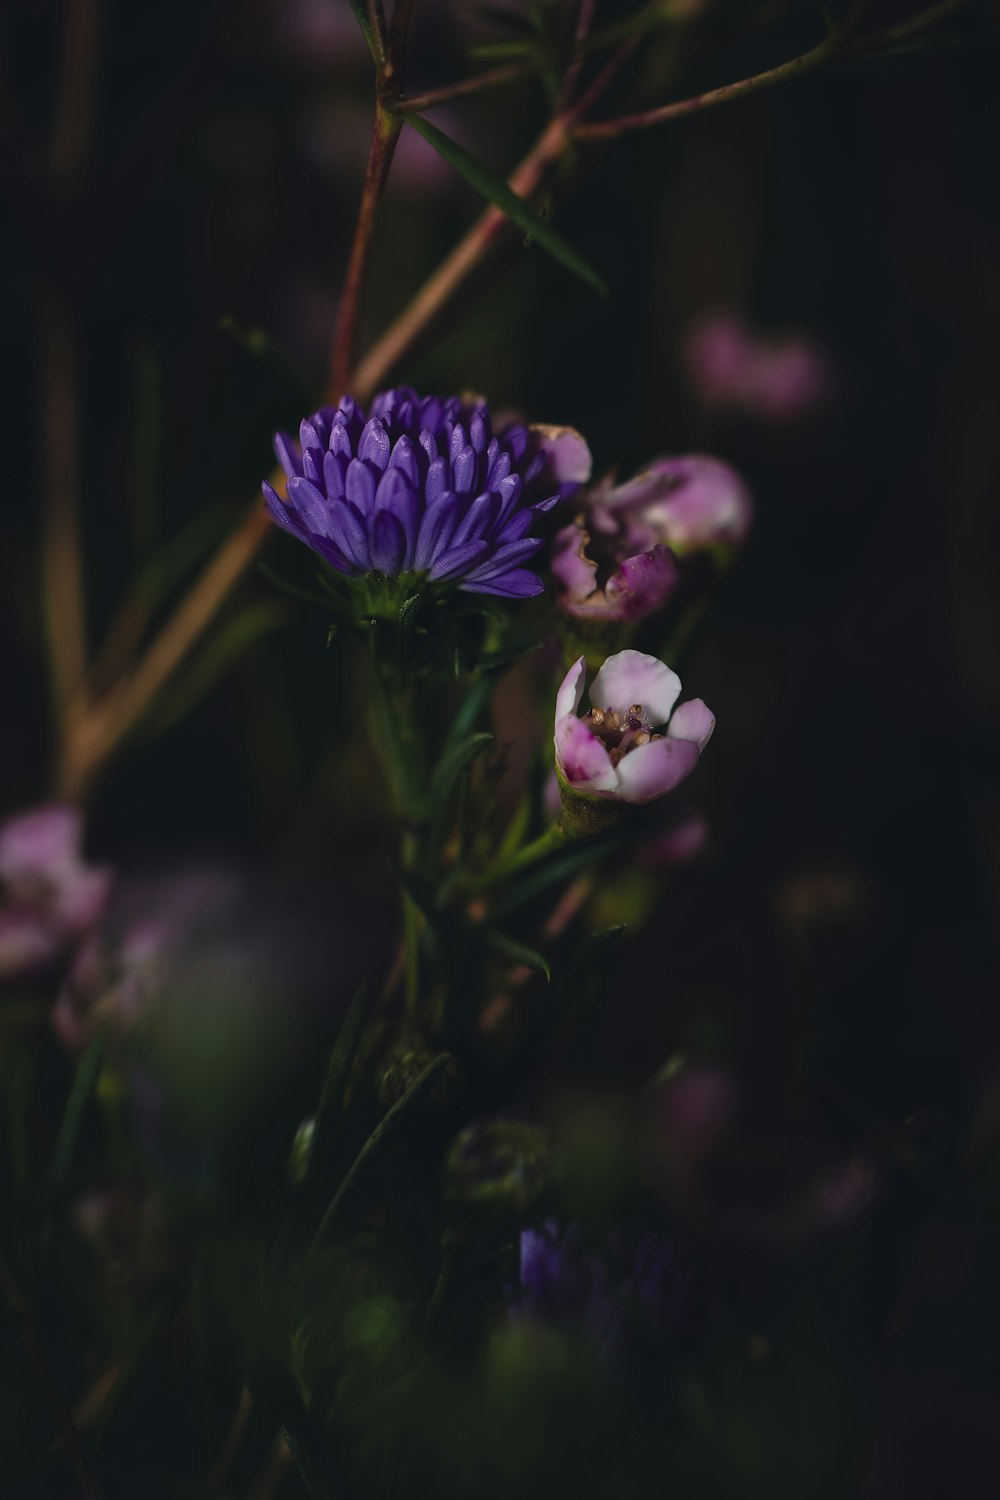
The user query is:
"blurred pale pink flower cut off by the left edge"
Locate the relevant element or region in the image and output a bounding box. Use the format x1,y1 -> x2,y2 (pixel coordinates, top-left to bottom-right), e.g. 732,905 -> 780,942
0,803 -> 111,980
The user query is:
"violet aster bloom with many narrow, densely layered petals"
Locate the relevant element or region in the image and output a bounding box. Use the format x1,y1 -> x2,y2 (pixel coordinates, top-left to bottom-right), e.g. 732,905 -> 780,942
264,386 -> 589,599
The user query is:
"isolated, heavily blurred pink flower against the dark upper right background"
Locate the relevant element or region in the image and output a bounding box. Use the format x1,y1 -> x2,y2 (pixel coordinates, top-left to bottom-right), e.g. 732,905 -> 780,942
684,312 -> 834,422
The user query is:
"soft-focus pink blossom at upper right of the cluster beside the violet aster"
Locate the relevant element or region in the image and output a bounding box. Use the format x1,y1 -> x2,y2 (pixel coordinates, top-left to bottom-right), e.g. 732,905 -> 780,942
588,453 -> 753,554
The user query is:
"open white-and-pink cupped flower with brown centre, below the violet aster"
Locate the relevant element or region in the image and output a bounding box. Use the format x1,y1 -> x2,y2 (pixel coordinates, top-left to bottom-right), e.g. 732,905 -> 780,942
555,651 -> 715,803
